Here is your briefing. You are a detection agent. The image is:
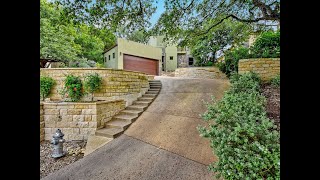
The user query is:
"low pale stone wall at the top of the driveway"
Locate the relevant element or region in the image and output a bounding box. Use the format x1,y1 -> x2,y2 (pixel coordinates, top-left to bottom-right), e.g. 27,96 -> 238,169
174,67 -> 227,79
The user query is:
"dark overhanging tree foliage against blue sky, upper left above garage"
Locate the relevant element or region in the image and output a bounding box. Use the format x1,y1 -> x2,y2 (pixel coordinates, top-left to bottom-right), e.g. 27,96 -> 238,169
57,0 -> 156,32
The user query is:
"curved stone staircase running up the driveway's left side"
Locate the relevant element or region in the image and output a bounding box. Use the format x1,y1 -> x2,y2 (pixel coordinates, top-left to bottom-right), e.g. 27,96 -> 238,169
95,80 -> 162,138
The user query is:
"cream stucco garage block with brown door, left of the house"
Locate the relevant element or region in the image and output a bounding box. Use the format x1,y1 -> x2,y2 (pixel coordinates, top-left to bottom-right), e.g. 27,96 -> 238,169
103,38 -> 162,75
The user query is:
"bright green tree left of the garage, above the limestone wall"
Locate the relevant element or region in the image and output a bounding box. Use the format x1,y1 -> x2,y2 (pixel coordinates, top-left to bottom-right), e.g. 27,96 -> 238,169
40,0 -> 116,63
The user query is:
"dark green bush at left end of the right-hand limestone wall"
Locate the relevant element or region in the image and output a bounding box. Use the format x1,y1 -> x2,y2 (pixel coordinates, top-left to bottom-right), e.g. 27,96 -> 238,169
217,47 -> 252,77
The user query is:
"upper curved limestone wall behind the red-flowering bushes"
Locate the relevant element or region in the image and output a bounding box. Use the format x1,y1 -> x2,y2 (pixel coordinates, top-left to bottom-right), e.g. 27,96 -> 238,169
40,68 -> 149,106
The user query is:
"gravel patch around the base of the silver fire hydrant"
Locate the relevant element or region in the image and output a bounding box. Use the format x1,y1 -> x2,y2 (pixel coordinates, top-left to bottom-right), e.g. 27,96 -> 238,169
40,141 -> 87,178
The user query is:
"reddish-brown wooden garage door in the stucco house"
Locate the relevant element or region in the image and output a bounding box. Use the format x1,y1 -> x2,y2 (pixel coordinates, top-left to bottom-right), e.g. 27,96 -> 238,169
123,54 -> 159,75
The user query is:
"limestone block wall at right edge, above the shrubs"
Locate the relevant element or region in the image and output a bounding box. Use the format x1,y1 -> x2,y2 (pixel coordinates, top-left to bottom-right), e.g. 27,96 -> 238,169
238,58 -> 280,81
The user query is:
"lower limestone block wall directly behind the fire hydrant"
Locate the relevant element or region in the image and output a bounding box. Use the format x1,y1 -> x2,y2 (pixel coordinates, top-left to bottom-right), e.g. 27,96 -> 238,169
43,100 -> 125,141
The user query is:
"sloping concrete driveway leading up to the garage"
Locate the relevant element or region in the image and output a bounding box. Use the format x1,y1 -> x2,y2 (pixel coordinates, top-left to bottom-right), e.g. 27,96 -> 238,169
43,76 -> 229,180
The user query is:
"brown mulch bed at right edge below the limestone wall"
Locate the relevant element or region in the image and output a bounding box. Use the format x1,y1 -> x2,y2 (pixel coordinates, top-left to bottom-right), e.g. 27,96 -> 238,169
261,84 -> 280,131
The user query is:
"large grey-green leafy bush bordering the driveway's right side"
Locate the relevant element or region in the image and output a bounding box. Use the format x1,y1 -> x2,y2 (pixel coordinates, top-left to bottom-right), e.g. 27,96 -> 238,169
198,73 -> 280,180
